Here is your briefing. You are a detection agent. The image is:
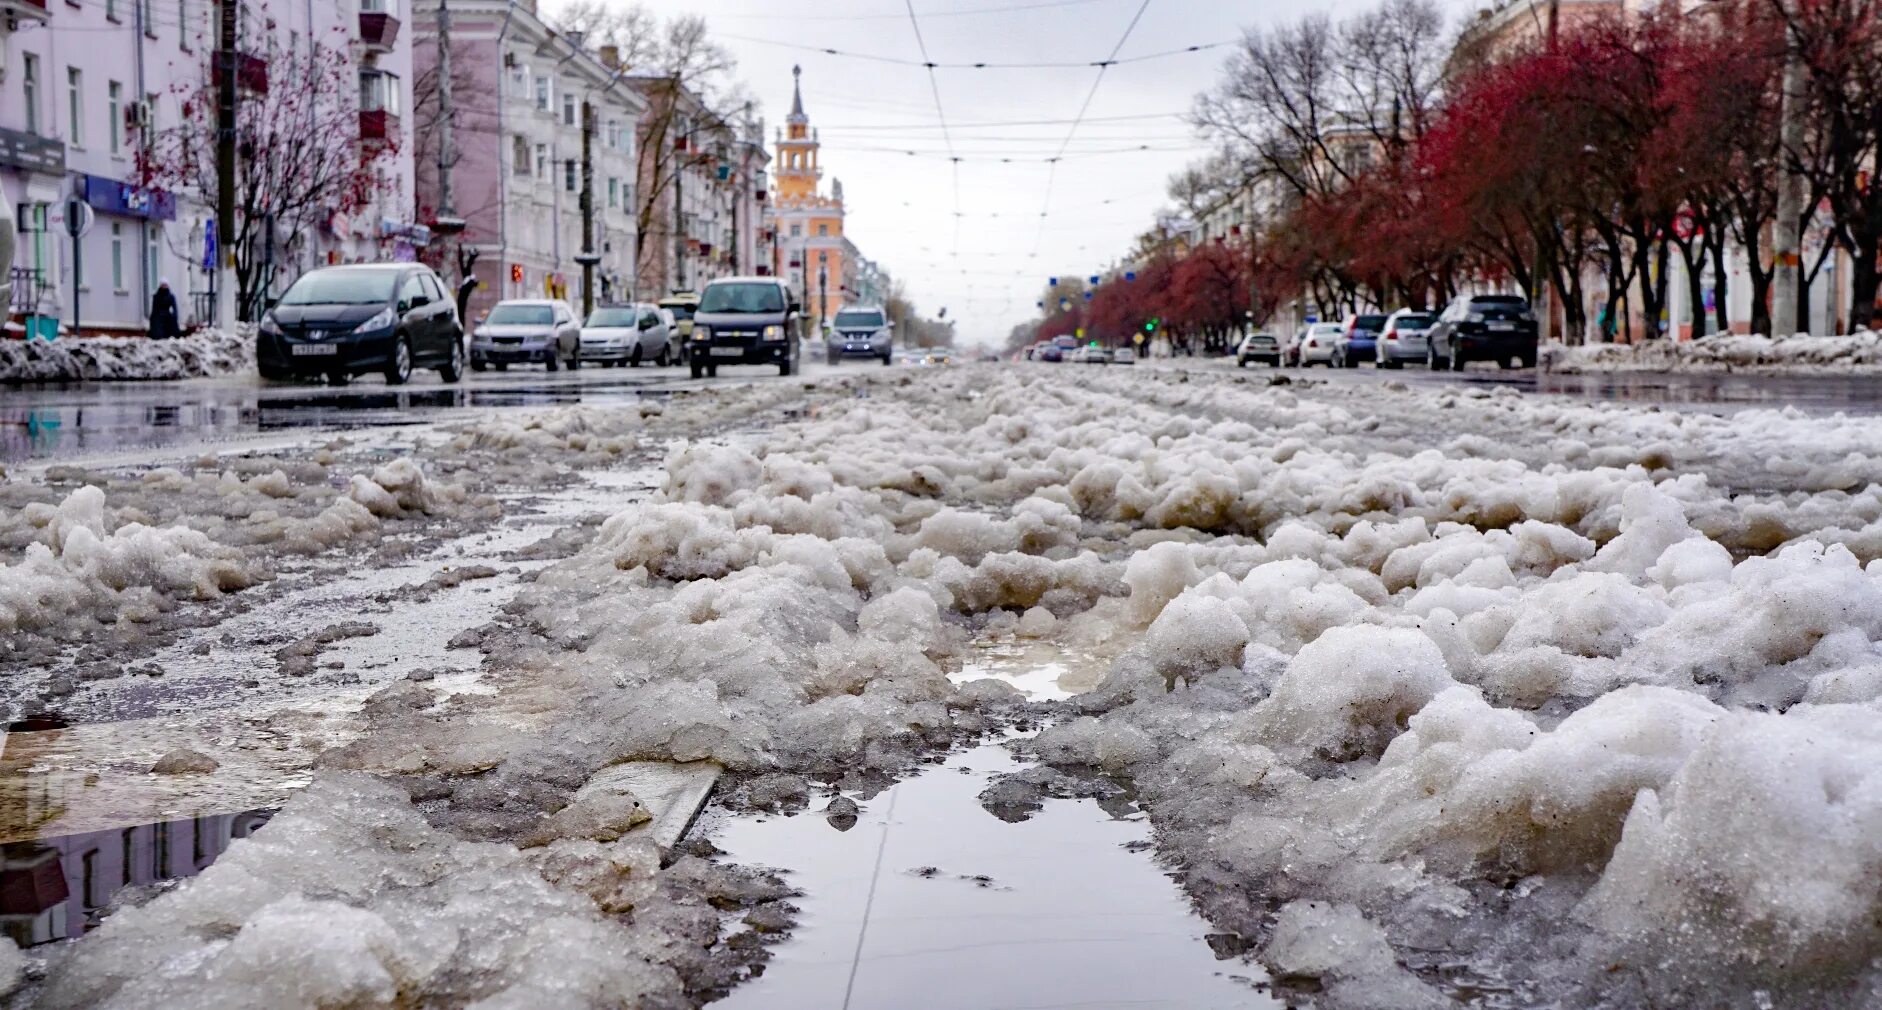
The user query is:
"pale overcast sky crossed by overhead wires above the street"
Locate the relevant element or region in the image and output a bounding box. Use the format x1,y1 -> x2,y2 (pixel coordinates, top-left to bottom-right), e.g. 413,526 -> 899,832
609,0 -> 1472,344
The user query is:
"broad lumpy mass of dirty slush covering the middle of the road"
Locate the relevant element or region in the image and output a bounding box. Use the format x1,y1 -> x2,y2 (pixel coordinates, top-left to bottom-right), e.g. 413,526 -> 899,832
18,367 -> 1882,1008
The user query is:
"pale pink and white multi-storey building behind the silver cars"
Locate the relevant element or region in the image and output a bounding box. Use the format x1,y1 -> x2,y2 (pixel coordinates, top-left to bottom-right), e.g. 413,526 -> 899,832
414,0 -> 646,324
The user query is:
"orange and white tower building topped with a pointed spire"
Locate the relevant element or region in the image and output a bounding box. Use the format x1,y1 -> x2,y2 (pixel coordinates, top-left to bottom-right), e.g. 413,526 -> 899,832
768,68 -> 854,331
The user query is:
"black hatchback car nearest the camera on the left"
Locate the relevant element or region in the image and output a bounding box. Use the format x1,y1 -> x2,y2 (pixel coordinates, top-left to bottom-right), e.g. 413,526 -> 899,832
254,263 -> 465,386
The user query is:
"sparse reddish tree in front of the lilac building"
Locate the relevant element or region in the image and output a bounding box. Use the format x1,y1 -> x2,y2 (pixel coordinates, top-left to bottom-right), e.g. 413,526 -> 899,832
137,41 -> 399,322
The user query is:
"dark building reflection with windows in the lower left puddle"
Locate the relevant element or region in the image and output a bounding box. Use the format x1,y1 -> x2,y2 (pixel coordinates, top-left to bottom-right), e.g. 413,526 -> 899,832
0,811 -> 273,946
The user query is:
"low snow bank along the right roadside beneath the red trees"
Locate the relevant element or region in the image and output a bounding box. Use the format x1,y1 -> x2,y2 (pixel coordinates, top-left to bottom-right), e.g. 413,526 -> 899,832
1541,331 -> 1882,374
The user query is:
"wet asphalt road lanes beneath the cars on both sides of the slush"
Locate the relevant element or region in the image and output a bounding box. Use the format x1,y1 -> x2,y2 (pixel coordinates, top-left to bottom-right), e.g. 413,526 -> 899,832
0,359 -> 1882,463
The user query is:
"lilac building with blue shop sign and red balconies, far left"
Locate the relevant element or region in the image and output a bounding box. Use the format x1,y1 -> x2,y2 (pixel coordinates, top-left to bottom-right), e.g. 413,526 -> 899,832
0,0 -> 415,333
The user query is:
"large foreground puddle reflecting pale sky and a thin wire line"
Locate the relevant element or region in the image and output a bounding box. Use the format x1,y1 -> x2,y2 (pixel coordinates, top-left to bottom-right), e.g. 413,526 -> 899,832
713,745 -> 1282,1010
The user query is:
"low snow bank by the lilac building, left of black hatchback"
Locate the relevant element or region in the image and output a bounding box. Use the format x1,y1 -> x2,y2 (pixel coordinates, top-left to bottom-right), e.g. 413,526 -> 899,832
0,327 -> 254,384
